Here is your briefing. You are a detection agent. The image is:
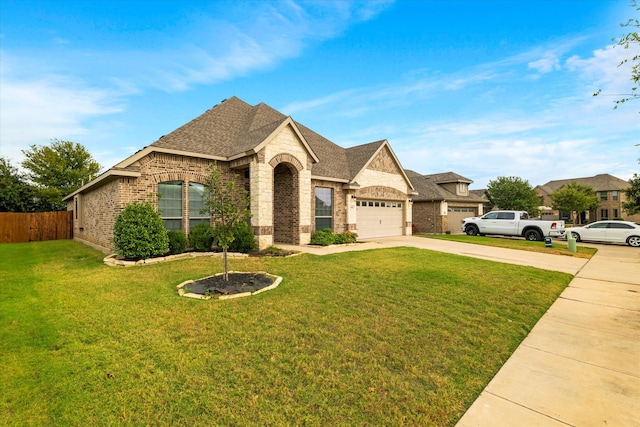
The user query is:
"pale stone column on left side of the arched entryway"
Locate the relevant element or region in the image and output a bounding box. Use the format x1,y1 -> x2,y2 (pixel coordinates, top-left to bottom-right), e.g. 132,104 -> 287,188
249,160 -> 273,250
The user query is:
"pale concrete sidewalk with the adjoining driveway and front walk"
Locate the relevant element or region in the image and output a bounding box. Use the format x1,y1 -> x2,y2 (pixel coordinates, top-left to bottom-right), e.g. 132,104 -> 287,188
279,236 -> 640,427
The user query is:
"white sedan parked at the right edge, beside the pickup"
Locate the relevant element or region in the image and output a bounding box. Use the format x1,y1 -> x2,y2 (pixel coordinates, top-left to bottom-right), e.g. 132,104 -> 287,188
567,221 -> 640,248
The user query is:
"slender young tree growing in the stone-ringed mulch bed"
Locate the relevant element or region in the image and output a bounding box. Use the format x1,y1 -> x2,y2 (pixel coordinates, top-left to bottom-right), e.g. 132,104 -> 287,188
203,163 -> 251,280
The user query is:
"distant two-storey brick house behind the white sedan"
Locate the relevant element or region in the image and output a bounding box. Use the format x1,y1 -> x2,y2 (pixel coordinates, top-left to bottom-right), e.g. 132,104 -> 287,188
535,174 -> 640,224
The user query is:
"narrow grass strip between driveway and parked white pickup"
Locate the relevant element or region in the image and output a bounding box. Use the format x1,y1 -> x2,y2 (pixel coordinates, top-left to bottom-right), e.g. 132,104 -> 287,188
414,234 -> 598,258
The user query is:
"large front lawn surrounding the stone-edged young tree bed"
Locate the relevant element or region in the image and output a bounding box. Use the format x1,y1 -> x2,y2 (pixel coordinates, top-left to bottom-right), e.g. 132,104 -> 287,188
0,241 -> 571,426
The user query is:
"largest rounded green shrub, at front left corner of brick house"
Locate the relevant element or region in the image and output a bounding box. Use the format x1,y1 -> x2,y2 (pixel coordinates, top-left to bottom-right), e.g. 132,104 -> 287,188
113,202 -> 169,259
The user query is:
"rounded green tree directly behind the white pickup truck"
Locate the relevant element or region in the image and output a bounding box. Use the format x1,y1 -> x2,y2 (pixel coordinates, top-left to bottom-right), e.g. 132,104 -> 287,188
487,176 -> 540,217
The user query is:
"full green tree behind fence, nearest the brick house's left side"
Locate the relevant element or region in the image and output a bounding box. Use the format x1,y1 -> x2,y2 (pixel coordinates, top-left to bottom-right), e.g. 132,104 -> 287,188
22,139 -> 101,210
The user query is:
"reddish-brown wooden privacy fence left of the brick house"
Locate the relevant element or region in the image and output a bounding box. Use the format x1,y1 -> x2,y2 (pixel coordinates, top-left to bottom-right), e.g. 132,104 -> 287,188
0,211 -> 73,243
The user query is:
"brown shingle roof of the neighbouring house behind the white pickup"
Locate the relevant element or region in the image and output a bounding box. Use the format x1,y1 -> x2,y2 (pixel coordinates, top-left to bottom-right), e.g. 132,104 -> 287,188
404,169 -> 486,203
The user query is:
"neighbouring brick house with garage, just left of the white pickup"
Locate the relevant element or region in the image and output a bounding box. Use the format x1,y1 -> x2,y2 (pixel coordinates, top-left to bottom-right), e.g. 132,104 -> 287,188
405,170 -> 489,233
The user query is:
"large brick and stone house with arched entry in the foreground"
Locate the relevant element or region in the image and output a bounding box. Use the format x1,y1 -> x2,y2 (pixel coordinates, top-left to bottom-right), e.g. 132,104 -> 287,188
65,97 -> 414,250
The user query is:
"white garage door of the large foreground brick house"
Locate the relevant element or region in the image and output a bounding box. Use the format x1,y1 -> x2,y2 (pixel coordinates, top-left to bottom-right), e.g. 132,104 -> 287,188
356,200 -> 402,239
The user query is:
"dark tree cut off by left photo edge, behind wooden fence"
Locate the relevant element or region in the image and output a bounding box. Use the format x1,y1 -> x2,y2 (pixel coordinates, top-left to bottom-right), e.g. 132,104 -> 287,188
0,157 -> 36,212
